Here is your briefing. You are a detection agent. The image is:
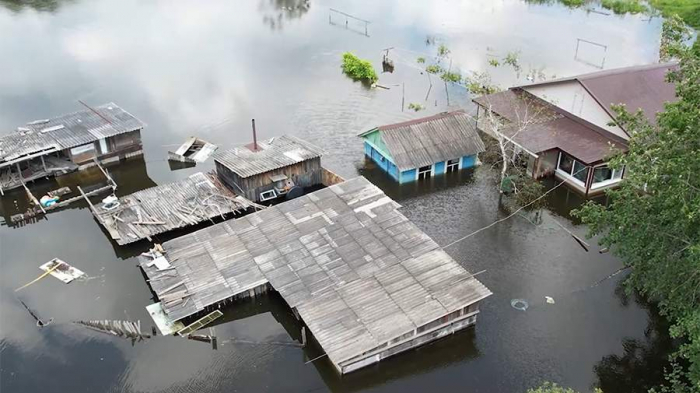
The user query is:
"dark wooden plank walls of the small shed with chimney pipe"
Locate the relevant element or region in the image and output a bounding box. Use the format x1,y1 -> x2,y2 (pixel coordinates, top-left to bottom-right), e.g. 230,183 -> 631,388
214,157 -> 323,202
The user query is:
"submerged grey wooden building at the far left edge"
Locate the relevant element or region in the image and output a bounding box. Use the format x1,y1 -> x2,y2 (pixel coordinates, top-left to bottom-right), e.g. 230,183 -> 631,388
0,103 -> 144,193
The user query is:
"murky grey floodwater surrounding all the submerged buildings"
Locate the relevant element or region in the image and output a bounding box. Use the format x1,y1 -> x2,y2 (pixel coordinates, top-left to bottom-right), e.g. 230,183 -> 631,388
0,0 -> 672,393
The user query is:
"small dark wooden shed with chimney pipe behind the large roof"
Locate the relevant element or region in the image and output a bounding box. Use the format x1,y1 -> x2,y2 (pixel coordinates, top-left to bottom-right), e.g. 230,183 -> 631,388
214,135 -> 332,202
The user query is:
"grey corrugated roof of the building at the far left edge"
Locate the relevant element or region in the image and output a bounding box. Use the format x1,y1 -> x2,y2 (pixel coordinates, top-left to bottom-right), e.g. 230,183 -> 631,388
0,102 -> 144,162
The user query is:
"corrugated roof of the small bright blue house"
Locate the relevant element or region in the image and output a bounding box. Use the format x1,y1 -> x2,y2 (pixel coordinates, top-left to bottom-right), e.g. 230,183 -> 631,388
377,110 -> 484,171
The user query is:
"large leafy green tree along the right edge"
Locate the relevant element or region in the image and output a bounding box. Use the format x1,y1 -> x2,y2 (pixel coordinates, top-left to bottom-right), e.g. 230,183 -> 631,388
575,16 -> 700,392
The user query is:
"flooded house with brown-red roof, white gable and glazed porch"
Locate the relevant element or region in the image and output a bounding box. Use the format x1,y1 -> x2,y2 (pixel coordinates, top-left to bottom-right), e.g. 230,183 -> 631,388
474,64 -> 676,197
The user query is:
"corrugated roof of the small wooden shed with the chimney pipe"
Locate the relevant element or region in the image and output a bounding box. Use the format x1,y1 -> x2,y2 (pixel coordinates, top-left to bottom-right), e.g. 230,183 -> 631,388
214,135 -> 323,178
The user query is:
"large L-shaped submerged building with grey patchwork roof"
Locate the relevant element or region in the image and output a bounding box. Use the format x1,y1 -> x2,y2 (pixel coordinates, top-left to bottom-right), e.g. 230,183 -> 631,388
140,177 -> 491,374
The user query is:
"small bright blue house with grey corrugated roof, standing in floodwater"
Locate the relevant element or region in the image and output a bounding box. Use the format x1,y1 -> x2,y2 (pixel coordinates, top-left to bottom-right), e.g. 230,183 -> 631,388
359,110 -> 484,183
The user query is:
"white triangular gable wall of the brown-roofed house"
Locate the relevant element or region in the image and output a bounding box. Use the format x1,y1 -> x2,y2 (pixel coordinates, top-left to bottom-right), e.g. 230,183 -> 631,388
524,80 -> 629,139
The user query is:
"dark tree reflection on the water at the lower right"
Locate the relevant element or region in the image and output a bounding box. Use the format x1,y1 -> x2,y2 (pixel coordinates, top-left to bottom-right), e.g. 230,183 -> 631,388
593,280 -> 677,393
